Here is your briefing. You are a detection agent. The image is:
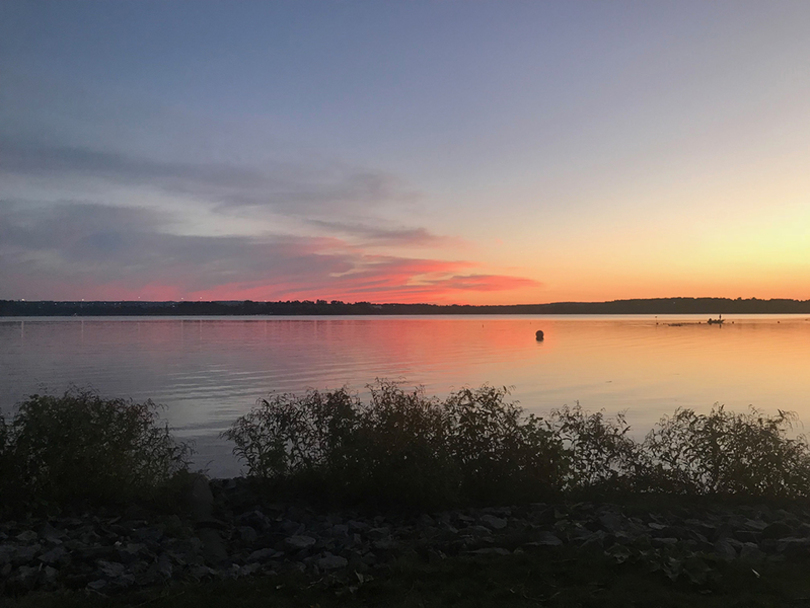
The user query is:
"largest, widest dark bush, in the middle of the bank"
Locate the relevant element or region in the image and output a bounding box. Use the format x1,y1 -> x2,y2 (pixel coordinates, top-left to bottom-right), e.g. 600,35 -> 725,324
223,382 -> 561,507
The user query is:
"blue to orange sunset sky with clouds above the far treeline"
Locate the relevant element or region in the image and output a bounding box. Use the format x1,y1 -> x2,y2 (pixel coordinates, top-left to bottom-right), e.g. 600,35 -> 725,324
0,0 -> 810,304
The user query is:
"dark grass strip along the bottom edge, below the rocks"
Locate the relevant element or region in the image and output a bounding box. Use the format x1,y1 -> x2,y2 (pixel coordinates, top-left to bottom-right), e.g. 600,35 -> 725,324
7,548 -> 810,608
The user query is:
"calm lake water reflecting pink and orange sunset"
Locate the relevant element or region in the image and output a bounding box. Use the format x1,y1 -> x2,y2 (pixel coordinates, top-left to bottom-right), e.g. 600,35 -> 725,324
0,315 -> 810,476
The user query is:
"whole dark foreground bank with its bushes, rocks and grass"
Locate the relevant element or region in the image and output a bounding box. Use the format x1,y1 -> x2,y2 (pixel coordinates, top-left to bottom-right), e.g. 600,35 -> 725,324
0,390 -> 810,608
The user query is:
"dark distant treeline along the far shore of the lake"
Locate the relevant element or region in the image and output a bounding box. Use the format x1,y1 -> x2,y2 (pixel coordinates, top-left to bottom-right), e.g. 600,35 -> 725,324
0,298 -> 810,317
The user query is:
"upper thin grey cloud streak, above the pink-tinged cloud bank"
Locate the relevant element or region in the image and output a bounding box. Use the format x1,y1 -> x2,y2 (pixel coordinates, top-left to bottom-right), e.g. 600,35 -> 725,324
0,138 -> 416,216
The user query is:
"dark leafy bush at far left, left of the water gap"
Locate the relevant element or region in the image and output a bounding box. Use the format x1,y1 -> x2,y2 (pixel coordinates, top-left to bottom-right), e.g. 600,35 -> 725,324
0,389 -> 190,504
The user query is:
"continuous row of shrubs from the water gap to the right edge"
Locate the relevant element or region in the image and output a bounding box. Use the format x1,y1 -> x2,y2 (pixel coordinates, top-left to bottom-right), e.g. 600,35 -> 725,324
224,381 -> 810,507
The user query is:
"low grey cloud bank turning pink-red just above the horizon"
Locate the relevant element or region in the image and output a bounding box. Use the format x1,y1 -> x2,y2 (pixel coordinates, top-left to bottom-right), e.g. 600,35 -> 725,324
0,200 -> 537,302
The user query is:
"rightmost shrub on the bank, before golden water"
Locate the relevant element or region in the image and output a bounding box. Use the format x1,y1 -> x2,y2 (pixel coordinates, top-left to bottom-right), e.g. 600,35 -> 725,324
642,405 -> 810,498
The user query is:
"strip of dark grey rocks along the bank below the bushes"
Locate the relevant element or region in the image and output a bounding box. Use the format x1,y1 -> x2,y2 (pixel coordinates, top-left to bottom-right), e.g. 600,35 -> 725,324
0,476 -> 810,595
